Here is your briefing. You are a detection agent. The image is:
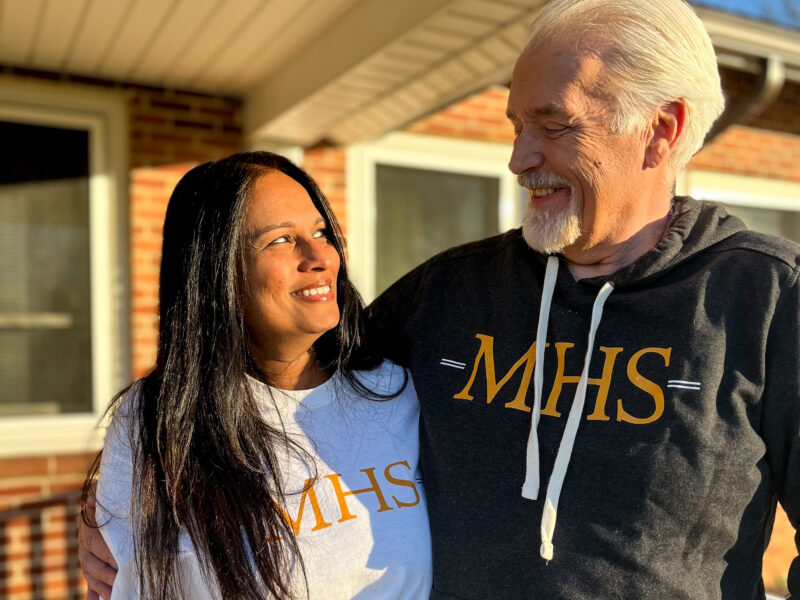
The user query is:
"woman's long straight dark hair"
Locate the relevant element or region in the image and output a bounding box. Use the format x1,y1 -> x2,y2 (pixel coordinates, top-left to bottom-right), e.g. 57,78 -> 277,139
87,152 -> 388,600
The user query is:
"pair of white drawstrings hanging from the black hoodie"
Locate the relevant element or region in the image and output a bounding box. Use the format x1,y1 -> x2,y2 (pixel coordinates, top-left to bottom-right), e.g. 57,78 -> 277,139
522,256 -> 614,561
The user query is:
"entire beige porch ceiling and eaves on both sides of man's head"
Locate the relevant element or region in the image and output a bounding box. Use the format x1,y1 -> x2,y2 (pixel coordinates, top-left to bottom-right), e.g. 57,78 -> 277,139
0,0 -> 800,146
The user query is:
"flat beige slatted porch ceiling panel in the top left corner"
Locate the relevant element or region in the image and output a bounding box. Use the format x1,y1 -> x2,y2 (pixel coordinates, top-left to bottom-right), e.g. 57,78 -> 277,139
0,0 -> 358,96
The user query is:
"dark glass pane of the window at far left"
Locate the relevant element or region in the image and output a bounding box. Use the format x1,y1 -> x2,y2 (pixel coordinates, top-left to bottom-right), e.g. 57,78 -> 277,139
0,122 -> 92,416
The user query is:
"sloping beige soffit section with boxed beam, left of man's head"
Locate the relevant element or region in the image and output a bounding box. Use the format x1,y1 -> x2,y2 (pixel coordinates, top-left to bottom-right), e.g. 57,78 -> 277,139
246,0 -> 544,145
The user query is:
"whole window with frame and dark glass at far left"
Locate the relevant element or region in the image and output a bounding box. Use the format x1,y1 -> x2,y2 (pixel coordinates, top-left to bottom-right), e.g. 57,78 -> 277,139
0,80 -> 129,455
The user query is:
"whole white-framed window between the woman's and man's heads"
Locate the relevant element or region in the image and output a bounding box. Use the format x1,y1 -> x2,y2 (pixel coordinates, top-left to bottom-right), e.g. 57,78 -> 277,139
347,133 -> 524,302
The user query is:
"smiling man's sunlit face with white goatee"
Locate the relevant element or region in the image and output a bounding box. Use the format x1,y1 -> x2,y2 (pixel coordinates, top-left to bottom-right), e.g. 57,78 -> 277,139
507,40 -> 645,253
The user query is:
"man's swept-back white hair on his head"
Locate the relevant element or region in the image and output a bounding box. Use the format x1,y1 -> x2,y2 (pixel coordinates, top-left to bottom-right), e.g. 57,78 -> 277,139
526,0 -> 725,177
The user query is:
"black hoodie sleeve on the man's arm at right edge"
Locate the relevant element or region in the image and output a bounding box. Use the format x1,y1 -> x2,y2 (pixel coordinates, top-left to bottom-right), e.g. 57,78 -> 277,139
762,268 -> 800,598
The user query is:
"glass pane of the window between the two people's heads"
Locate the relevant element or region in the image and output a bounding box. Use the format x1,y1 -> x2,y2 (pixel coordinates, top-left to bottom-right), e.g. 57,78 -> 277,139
375,164 -> 500,294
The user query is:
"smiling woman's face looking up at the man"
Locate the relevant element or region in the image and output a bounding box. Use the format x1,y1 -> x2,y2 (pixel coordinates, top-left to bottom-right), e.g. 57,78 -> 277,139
244,171 -> 339,360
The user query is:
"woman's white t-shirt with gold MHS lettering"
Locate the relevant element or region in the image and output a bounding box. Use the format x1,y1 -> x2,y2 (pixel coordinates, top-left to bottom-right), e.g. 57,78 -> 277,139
97,361 -> 432,600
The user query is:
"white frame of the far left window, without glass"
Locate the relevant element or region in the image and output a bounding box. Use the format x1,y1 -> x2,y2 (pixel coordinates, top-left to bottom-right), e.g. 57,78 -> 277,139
0,77 -> 131,457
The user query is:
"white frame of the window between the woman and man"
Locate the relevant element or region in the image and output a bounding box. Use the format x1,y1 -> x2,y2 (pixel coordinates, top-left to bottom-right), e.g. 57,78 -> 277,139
346,132 -> 522,303
